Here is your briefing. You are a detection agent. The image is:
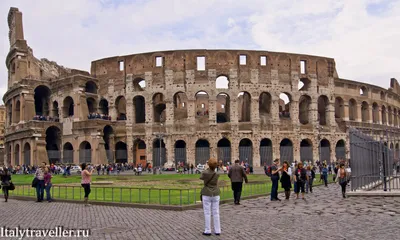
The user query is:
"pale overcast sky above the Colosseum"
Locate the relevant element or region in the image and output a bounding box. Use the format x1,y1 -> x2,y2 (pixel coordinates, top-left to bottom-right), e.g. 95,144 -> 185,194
0,0 -> 400,102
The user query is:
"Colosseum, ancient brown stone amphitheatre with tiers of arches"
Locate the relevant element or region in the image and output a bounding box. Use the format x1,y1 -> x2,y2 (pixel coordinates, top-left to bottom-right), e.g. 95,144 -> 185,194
3,8 -> 400,167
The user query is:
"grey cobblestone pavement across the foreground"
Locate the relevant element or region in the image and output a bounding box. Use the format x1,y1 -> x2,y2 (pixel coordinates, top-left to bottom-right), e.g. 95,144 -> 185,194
0,185 -> 400,240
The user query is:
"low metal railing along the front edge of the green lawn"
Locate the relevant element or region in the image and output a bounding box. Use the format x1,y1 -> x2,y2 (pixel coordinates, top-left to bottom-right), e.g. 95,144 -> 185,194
10,183 -> 271,206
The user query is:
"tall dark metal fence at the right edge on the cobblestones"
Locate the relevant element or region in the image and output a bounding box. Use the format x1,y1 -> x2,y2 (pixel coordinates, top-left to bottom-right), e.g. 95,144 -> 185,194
350,128 -> 400,191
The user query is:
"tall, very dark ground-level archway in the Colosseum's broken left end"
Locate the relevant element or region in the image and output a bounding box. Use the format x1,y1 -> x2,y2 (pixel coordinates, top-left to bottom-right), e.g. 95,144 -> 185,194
46,126 -> 61,163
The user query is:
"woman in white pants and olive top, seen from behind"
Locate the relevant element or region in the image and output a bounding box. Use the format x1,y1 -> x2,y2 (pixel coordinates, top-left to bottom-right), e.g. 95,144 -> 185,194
200,158 -> 221,236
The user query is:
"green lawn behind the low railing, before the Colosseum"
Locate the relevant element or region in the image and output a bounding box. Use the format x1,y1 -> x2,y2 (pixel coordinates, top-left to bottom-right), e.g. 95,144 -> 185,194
8,174 -> 328,205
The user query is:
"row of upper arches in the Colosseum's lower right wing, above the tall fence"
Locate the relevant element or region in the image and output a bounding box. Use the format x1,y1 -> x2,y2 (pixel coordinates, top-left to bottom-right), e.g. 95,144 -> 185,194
335,97 -> 399,126
